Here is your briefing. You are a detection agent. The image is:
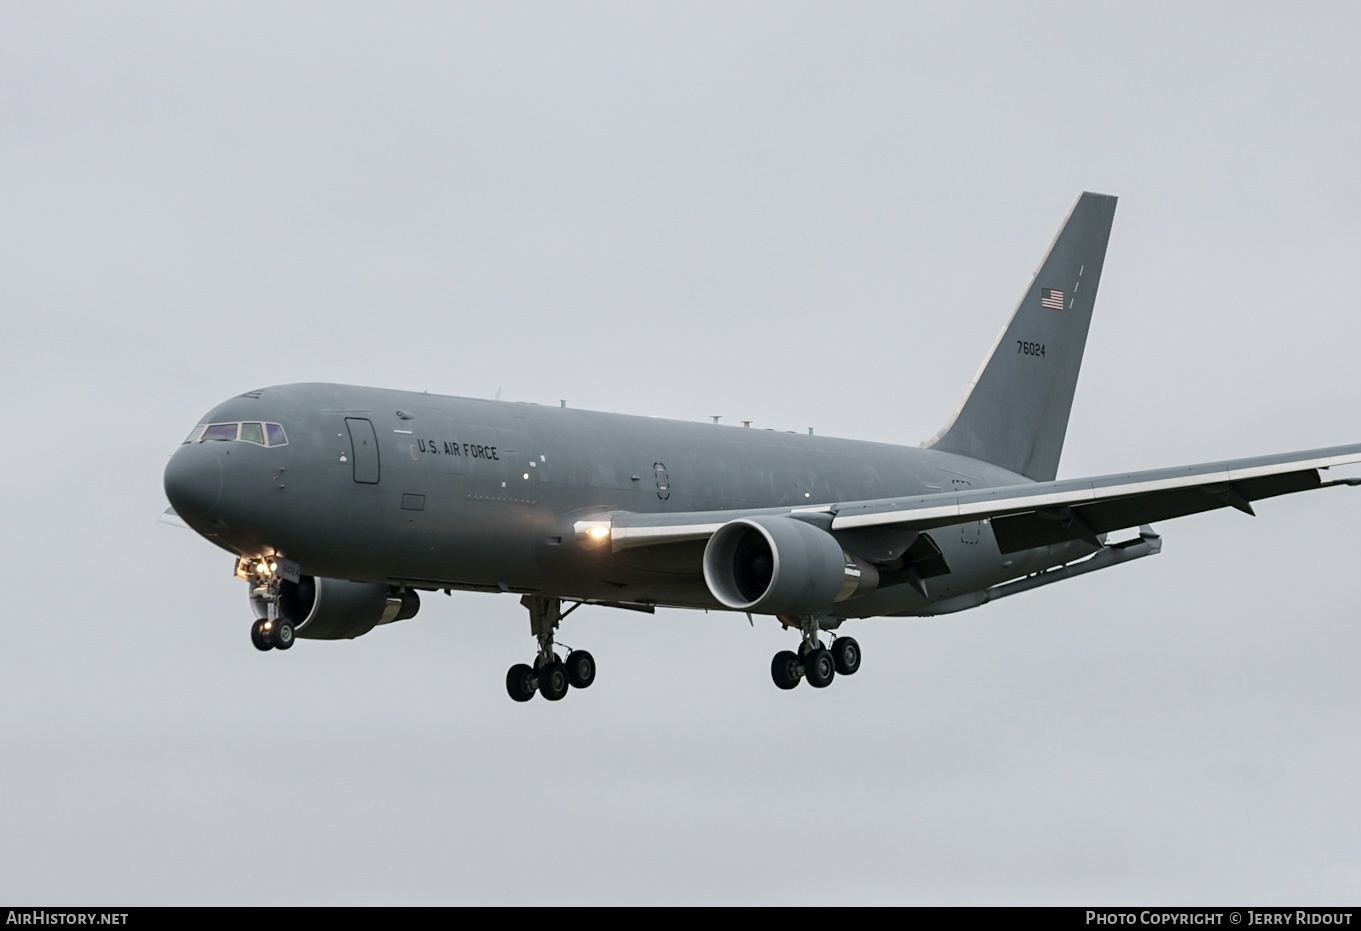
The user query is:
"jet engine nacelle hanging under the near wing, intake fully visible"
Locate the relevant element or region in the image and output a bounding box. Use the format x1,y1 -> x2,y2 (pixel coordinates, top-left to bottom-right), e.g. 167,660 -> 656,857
704,517 -> 879,615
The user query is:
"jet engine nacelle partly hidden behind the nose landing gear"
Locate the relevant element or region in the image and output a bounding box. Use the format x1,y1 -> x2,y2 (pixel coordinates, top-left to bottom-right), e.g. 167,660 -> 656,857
250,576 -> 421,640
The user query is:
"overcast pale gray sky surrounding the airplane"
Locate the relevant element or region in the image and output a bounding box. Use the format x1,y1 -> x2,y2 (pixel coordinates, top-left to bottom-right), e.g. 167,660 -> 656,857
0,0 -> 1361,904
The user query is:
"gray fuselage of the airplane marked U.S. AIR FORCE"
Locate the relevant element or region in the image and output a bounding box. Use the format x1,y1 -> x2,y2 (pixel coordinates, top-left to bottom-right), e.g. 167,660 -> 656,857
166,384 -> 1093,617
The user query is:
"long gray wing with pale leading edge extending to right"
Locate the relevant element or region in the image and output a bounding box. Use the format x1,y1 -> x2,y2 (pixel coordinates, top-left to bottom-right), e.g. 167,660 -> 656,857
590,444 -> 1361,553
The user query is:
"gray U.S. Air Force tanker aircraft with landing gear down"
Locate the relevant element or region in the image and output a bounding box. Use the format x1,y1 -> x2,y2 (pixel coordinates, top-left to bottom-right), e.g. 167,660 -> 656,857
163,193 -> 1361,701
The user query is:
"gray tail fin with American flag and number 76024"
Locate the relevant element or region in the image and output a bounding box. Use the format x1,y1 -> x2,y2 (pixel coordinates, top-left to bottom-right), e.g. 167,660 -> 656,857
921,193 -> 1116,482
